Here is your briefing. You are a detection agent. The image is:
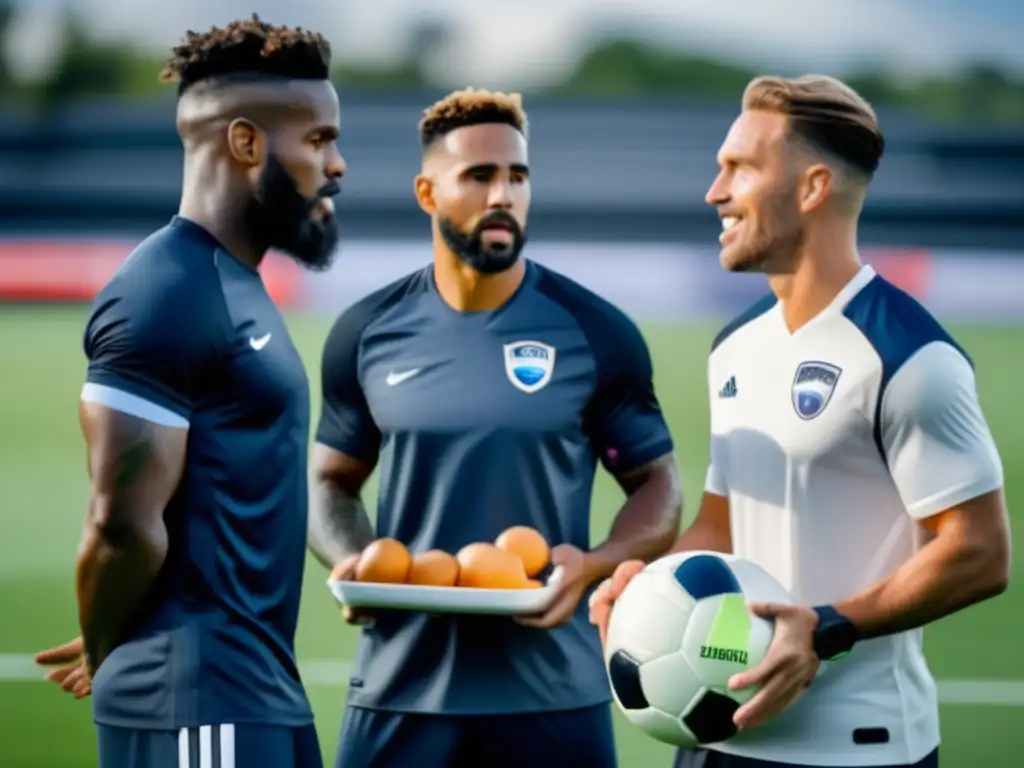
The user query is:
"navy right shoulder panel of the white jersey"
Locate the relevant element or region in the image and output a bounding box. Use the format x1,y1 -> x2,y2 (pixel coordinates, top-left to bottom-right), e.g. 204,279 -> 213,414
843,275 -> 973,388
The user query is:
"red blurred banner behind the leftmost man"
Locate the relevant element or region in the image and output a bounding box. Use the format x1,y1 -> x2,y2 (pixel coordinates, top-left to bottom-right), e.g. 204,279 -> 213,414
0,240 -> 302,306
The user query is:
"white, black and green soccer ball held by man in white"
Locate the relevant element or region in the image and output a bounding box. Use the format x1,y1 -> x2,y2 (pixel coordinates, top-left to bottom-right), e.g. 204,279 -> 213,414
604,551 -> 792,746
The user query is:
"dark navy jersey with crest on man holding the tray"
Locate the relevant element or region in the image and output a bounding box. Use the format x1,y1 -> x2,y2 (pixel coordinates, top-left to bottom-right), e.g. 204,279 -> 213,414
316,262 -> 672,715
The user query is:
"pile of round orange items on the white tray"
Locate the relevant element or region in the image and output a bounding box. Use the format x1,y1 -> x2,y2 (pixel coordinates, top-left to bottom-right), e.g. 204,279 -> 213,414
344,525 -> 551,590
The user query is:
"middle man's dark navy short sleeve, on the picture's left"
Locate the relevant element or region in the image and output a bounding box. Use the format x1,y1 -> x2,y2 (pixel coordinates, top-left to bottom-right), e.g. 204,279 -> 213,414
316,305 -> 381,462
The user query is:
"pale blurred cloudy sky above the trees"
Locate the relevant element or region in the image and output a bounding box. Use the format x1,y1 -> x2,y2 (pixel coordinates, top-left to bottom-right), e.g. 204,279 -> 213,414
5,0 -> 1024,88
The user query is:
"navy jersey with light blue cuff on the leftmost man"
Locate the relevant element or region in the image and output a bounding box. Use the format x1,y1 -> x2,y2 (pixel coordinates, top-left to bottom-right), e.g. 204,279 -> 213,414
83,217 -> 312,728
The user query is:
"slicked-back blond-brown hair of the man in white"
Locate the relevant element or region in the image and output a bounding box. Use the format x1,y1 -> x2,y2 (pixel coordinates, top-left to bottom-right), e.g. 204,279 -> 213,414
742,75 -> 885,183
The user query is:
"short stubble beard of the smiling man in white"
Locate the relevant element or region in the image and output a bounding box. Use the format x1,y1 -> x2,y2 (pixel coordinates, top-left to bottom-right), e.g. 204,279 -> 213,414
719,188 -> 804,274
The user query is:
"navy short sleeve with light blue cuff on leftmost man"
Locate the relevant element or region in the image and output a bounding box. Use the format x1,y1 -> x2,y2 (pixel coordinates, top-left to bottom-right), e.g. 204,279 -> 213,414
82,279 -> 212,427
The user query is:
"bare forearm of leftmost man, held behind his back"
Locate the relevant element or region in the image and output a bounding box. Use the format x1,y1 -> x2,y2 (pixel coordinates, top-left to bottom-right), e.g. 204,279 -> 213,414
76,502 -> 167,669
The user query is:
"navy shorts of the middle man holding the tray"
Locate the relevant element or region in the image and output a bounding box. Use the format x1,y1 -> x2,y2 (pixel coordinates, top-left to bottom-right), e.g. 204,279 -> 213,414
335,705 -> 615,768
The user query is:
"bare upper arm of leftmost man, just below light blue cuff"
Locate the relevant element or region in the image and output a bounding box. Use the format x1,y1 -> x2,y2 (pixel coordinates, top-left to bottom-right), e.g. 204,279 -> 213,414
79,401 -> 188,527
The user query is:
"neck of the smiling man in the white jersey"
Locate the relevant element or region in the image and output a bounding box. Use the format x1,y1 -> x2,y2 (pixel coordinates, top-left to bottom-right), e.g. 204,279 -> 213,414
768,222 -> 862,333
